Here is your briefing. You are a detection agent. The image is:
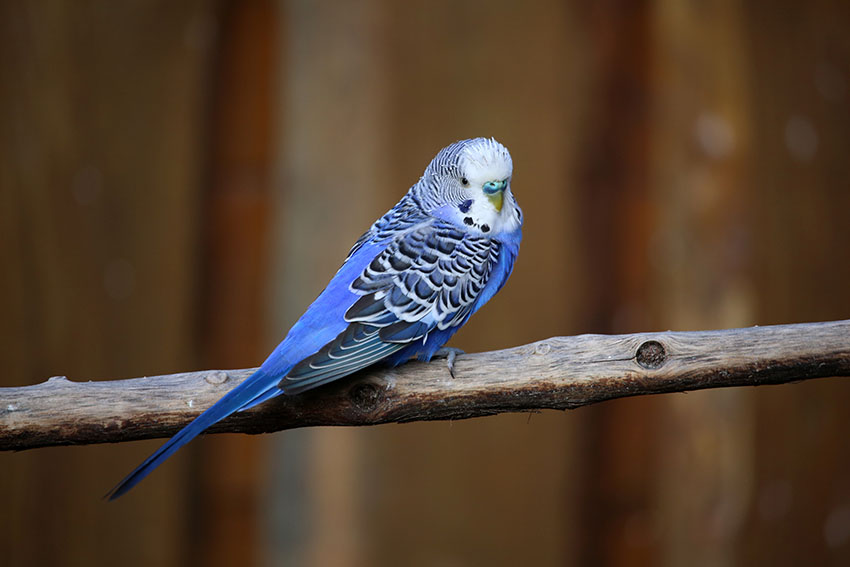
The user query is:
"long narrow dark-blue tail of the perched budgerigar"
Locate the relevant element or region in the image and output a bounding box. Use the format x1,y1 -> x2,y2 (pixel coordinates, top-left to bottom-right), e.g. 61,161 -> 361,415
106,370 -> 280,500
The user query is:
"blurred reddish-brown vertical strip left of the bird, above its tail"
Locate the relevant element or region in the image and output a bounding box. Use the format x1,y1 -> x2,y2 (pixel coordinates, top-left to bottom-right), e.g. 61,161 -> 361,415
190,0 -> 279,566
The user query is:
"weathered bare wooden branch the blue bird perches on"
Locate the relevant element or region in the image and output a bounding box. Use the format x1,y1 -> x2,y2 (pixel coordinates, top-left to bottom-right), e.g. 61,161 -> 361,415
0,320 -> 850,450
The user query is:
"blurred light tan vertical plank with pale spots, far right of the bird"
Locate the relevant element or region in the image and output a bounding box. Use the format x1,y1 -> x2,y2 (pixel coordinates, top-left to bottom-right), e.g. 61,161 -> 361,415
649,0 -> 761,566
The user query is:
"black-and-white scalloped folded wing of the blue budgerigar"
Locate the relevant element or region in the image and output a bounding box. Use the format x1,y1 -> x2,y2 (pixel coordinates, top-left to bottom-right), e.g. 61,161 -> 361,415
279,219 -> 501,394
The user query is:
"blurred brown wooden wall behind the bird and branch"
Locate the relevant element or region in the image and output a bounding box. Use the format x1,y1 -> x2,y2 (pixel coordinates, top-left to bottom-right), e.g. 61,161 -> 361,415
0,0 -> 850,566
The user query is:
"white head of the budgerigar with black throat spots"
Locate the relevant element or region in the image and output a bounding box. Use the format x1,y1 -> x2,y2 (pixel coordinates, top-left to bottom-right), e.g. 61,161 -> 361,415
412,138 -> 522,236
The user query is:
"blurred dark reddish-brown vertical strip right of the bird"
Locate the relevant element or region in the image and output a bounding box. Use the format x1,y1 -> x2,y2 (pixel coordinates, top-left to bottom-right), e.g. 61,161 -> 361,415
575,0 -> 661,566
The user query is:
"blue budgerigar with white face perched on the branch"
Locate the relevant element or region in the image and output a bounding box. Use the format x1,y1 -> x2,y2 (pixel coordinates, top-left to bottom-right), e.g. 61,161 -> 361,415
106,138 -> 523,500
